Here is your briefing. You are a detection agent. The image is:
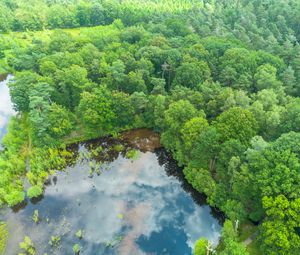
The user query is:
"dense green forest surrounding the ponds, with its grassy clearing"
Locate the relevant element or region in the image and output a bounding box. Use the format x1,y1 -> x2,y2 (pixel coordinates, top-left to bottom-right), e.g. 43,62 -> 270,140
0,0 -> 300,255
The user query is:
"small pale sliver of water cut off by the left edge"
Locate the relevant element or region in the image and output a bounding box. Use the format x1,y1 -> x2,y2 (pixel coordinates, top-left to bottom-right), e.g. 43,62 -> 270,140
0,75 -> 15,145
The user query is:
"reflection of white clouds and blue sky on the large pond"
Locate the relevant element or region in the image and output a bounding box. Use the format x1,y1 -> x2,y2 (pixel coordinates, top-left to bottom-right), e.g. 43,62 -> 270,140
7,152 -> 220,255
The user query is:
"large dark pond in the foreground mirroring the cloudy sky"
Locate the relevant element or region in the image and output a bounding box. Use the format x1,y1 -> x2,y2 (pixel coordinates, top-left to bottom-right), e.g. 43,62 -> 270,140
1,136 -> 221,255
